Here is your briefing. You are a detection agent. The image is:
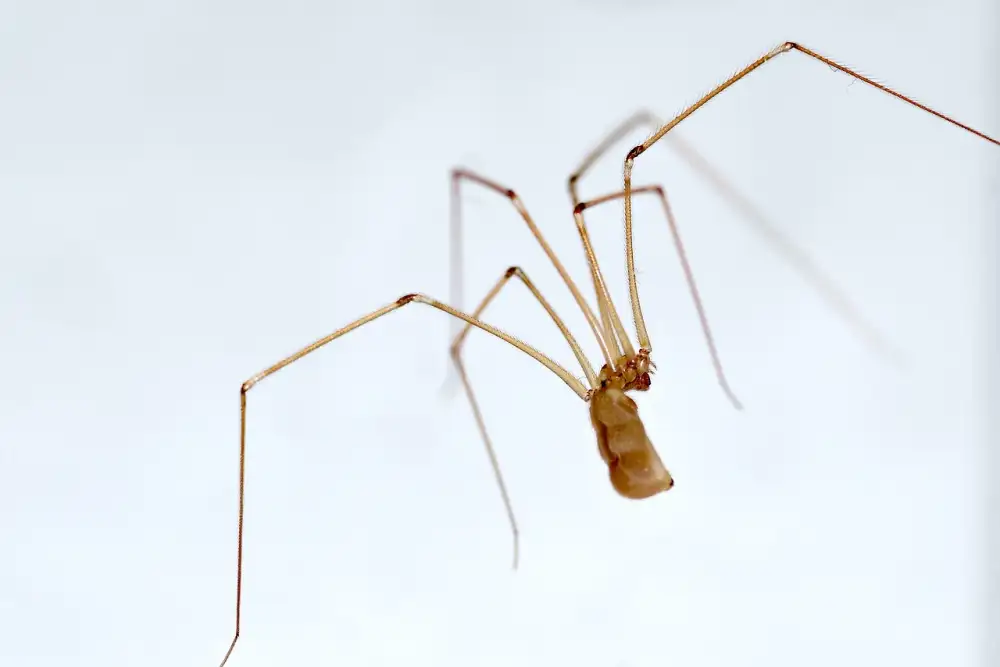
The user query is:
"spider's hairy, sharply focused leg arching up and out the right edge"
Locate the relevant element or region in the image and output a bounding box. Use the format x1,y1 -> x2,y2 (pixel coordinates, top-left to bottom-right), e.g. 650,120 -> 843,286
624,42 -> 1000,350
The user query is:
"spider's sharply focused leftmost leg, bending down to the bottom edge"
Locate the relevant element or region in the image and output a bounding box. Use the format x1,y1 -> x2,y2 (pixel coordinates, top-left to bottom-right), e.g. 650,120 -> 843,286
219,294 -> 589,667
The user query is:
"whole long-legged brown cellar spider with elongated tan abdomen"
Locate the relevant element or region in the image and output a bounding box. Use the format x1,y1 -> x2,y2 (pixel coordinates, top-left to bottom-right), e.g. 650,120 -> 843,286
220,42 -> 1000,667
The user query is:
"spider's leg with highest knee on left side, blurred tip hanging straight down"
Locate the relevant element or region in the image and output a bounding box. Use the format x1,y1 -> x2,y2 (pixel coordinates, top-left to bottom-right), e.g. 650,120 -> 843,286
451,169 -> 615,367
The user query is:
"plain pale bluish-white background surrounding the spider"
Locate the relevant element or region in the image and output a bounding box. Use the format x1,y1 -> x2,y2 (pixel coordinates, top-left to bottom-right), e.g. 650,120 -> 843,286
0,0 -> 1000,667
